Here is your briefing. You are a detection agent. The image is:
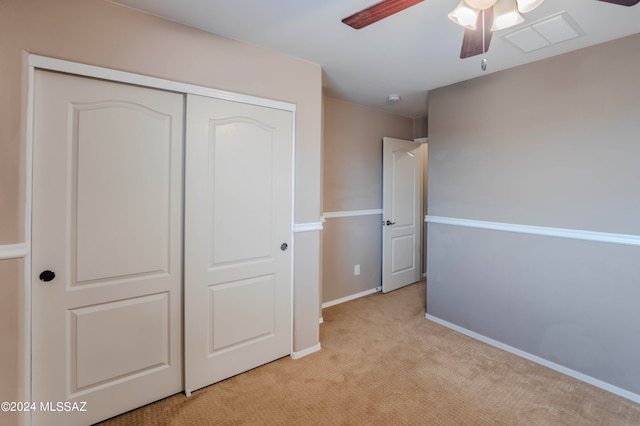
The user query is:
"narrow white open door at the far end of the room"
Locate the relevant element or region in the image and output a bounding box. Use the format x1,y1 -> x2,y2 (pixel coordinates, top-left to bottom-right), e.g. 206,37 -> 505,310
382,137 -> 422,293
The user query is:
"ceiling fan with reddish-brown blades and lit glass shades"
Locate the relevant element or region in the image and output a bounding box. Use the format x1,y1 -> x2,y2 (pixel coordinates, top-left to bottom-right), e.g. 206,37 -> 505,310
342,0 -> 640,59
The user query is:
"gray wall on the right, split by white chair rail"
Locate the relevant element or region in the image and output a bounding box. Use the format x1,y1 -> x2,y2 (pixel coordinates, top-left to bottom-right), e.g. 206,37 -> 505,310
427,35 -> 640,394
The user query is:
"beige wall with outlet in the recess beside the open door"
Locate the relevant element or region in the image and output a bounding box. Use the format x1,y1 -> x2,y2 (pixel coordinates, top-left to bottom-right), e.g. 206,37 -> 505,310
322,97 -> 414,302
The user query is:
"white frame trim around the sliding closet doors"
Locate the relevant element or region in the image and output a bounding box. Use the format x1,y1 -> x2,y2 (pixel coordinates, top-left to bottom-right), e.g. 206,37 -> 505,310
19,54 -> 298,425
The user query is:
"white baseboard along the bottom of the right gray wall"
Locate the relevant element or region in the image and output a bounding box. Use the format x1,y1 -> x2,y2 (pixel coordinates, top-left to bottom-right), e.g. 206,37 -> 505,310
425,314 -> 640,403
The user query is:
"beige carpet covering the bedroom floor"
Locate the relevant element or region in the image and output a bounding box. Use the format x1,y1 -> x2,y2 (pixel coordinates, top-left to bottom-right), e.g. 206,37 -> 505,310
99,283 -> 640,426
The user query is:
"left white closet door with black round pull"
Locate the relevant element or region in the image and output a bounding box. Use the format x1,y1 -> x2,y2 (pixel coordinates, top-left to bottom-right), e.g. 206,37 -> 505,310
31,71 -> 184,426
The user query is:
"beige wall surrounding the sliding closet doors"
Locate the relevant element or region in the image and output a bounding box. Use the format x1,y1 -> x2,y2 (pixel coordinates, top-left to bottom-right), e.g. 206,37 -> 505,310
0,0 -> 322,416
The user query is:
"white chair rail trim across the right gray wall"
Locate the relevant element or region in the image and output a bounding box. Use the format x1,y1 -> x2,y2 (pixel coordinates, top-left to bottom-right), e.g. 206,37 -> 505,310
424,215 -> 640,246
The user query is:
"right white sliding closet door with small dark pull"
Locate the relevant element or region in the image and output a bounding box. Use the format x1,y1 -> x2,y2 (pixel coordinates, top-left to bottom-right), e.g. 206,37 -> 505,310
185,95 -> 293,394
